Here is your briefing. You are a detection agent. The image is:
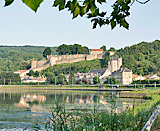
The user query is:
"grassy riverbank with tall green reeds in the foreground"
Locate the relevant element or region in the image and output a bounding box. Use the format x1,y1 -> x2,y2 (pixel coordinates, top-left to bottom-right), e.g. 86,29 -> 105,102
42,90 -> 160,131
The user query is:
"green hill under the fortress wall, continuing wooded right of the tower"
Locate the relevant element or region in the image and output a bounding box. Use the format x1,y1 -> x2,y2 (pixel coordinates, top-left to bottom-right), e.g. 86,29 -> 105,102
42,40 -> 160,79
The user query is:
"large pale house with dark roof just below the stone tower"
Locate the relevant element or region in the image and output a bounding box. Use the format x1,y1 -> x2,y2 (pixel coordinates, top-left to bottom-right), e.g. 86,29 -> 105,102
110,68 -> 132,84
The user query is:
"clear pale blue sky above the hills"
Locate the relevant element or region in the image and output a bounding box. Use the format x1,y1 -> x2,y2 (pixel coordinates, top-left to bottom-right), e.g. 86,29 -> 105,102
0,0 -> 160,49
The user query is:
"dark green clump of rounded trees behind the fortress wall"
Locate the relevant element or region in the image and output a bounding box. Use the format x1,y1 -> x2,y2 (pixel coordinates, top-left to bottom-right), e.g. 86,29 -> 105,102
56,44 -> 89,55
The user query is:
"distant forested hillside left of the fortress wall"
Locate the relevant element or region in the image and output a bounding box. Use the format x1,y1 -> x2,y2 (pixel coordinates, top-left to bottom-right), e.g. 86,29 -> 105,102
0,46 -> 56,72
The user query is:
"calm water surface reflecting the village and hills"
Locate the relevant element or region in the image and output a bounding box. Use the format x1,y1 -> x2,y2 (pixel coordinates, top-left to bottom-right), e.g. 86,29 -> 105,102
0,90 -> 144,131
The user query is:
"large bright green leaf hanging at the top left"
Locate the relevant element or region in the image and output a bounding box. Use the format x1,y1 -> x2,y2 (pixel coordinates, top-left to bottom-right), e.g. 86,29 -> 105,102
22,0 -> 43,12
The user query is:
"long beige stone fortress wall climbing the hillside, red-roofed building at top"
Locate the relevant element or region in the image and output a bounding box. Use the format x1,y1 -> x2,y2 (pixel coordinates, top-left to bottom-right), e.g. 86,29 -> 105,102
31,49 -> 105,71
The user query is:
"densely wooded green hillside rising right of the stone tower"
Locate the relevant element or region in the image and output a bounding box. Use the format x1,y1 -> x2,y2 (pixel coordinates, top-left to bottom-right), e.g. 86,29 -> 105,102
117,40 -> 160,75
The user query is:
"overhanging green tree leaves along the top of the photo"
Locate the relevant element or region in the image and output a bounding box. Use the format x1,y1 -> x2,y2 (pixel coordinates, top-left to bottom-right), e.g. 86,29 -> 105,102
5,0 -> 150,29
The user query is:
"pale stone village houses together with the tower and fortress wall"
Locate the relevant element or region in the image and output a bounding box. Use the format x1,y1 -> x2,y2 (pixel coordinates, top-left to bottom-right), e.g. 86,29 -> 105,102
14,49 -> 160,85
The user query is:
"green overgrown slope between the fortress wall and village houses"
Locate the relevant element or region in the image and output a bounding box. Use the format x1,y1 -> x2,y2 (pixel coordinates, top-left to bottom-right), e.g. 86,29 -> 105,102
41,59 -> 102,84
